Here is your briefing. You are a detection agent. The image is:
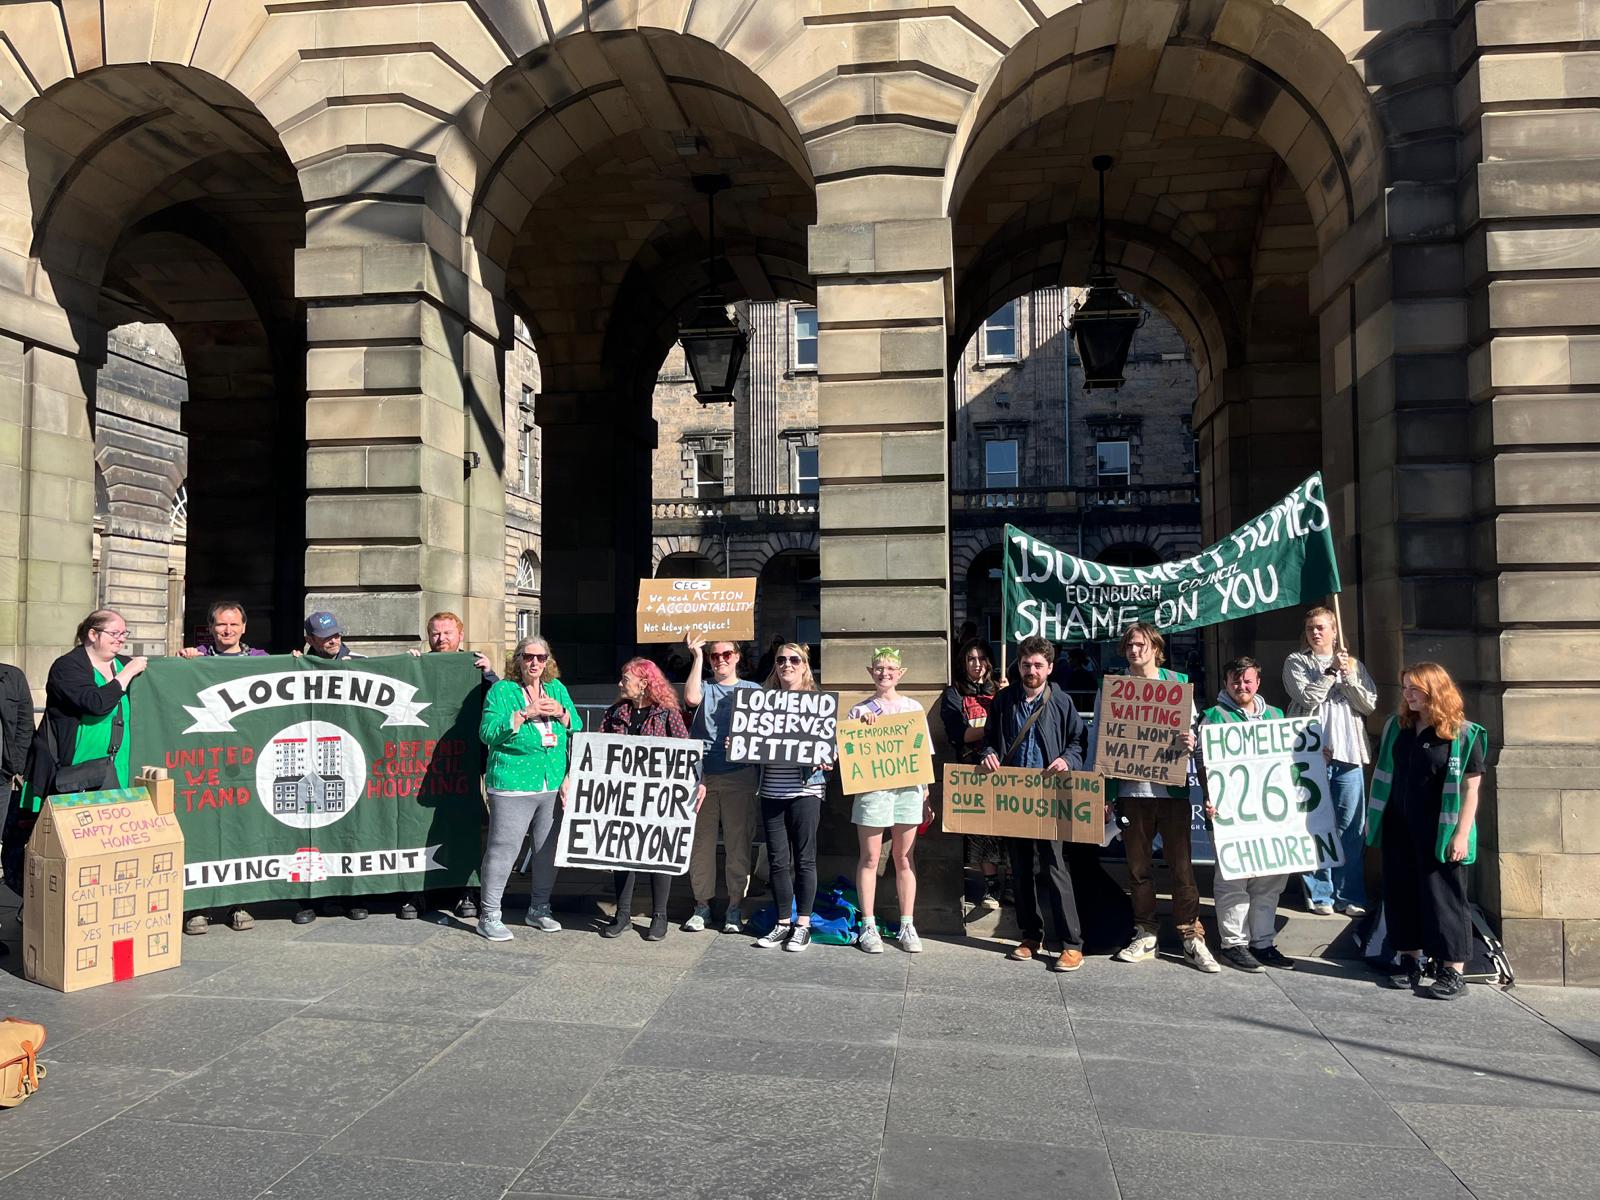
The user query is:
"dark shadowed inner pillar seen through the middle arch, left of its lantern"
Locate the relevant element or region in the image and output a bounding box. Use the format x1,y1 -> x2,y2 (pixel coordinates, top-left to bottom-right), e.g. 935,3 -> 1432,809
534,392 -> 656,683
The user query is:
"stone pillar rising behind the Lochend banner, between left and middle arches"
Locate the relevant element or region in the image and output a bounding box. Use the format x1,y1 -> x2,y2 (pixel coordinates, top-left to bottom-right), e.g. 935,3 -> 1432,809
296,240 -> 509,653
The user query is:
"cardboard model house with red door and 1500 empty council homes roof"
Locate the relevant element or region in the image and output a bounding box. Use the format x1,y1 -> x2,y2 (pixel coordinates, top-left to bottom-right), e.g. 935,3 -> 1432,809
22,787 -> 184,992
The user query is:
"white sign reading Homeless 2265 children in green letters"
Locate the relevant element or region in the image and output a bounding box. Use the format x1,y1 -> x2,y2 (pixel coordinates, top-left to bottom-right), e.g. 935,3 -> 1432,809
1200,717 -> 1344,878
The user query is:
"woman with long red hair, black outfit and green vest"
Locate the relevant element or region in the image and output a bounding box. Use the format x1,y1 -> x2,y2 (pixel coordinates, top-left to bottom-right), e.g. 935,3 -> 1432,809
1366,662 -> 1490,1000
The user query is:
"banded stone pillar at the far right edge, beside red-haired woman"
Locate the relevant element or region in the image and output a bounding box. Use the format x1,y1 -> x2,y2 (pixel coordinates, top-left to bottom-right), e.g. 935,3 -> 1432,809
1465,0 -> 1600,986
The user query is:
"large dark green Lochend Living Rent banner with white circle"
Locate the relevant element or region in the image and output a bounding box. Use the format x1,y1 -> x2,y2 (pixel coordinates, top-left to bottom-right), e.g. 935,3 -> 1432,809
131,654 -> 483,910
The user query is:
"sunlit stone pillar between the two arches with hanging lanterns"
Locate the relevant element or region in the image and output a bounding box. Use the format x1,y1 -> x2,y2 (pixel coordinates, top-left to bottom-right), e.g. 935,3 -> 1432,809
810,209 -> 962,931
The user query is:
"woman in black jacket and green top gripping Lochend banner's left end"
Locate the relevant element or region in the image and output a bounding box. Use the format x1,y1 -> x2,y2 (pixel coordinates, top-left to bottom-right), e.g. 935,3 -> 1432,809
5,608 -> 147,894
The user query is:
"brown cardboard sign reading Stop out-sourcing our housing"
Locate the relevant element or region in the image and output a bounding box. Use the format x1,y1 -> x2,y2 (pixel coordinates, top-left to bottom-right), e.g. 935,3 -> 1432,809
944,763 -> 1106,843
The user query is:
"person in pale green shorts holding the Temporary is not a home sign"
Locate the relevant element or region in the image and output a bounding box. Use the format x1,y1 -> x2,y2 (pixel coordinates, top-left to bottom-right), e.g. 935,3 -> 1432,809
850,646 -> 933,954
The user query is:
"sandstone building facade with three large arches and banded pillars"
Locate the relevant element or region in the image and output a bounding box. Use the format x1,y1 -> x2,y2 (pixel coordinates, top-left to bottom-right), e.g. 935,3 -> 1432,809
0,0 -> 1600,982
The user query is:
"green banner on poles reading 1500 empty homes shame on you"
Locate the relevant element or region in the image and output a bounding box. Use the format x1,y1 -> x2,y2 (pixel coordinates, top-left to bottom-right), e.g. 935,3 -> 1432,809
1002,472 -> 1339,645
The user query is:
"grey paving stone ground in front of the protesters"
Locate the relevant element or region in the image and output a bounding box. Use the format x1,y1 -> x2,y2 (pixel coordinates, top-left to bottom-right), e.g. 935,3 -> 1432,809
0,893 -> 1600,1200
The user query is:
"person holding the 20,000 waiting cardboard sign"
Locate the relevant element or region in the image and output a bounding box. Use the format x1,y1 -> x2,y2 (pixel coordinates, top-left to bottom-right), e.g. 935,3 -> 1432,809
1106,621 -> 1222,974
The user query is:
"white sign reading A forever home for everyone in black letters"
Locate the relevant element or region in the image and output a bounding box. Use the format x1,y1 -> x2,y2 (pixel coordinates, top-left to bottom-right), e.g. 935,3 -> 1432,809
555,733 -> 706,875
